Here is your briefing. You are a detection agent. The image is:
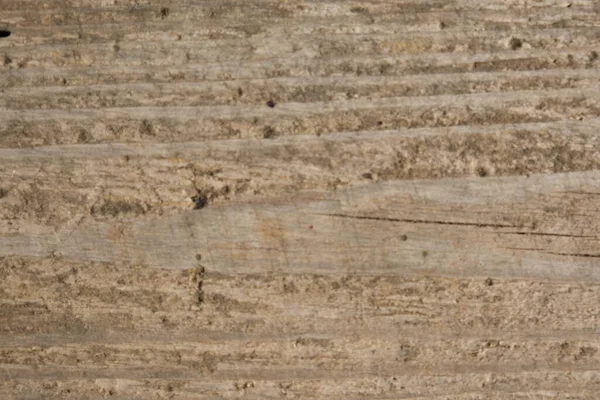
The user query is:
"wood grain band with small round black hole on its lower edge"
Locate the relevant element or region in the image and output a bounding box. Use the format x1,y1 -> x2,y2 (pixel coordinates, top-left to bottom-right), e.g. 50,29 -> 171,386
0,70 -> 600,110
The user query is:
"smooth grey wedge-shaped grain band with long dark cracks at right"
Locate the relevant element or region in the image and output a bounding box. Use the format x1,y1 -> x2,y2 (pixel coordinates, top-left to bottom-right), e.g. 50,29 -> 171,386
0,172 -> 600,282
